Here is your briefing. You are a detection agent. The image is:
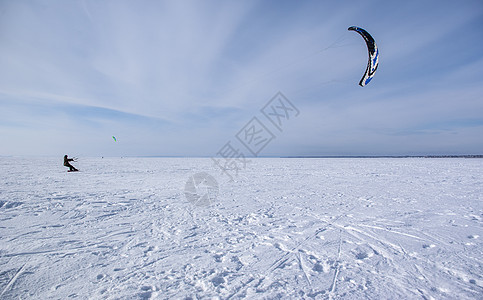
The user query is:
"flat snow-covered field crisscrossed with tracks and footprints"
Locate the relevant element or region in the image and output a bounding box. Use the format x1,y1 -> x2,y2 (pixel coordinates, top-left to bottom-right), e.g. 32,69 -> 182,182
0,157 -> 483,299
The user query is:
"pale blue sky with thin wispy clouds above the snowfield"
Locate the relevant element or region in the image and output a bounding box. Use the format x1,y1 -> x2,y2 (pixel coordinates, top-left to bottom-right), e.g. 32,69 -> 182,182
0,0 -> 483,156
